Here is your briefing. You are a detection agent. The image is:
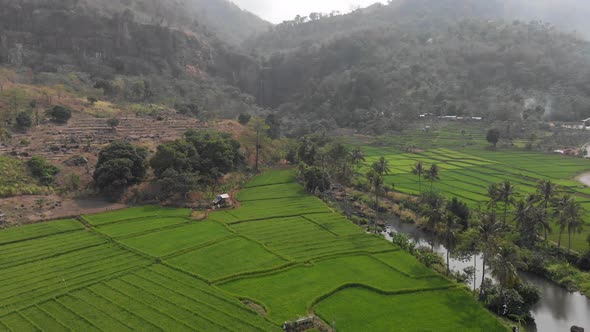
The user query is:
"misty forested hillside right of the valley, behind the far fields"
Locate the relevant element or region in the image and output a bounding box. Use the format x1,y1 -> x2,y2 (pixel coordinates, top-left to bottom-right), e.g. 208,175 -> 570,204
248,0 -> 590,132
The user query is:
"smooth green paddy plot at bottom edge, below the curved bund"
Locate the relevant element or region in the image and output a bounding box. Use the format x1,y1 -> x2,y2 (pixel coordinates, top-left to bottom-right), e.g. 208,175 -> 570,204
316,288 -> 506,332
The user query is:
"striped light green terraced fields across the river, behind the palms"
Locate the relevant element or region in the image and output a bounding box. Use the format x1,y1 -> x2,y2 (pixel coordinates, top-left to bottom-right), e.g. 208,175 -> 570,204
362,146 -> 590,251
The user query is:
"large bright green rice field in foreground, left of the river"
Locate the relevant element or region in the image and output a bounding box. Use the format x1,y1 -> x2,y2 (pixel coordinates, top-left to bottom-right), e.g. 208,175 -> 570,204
0,170 -> 506,332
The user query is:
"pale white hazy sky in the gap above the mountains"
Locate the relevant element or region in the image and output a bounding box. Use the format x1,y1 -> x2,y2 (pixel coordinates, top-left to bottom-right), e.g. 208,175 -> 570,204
232,0 -> 386,23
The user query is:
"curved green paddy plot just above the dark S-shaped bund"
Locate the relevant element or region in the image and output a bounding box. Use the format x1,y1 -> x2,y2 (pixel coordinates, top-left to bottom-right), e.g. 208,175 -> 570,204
220,256 -> 449,323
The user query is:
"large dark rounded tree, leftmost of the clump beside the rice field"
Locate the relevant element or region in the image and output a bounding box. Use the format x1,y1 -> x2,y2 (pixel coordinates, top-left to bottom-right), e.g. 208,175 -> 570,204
93,141 -> 147,199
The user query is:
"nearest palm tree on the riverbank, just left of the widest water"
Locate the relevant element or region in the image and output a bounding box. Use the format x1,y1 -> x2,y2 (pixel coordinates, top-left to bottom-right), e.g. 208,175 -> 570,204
490,245 -> 525,297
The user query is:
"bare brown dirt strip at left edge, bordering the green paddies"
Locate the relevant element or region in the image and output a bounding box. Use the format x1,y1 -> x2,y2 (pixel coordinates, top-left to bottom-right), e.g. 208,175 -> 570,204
0,195 -> 127,225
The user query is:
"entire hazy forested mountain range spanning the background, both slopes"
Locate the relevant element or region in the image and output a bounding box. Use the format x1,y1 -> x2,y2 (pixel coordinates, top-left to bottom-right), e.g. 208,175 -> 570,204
0,0 -> 590,136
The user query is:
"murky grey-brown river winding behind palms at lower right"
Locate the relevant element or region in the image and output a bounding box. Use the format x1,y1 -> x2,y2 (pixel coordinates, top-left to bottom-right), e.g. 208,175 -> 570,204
384,218 -> 590,332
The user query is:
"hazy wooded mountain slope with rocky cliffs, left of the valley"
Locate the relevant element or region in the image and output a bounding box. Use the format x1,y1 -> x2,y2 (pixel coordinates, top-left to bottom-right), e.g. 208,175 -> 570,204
0,0 -> 258,117
